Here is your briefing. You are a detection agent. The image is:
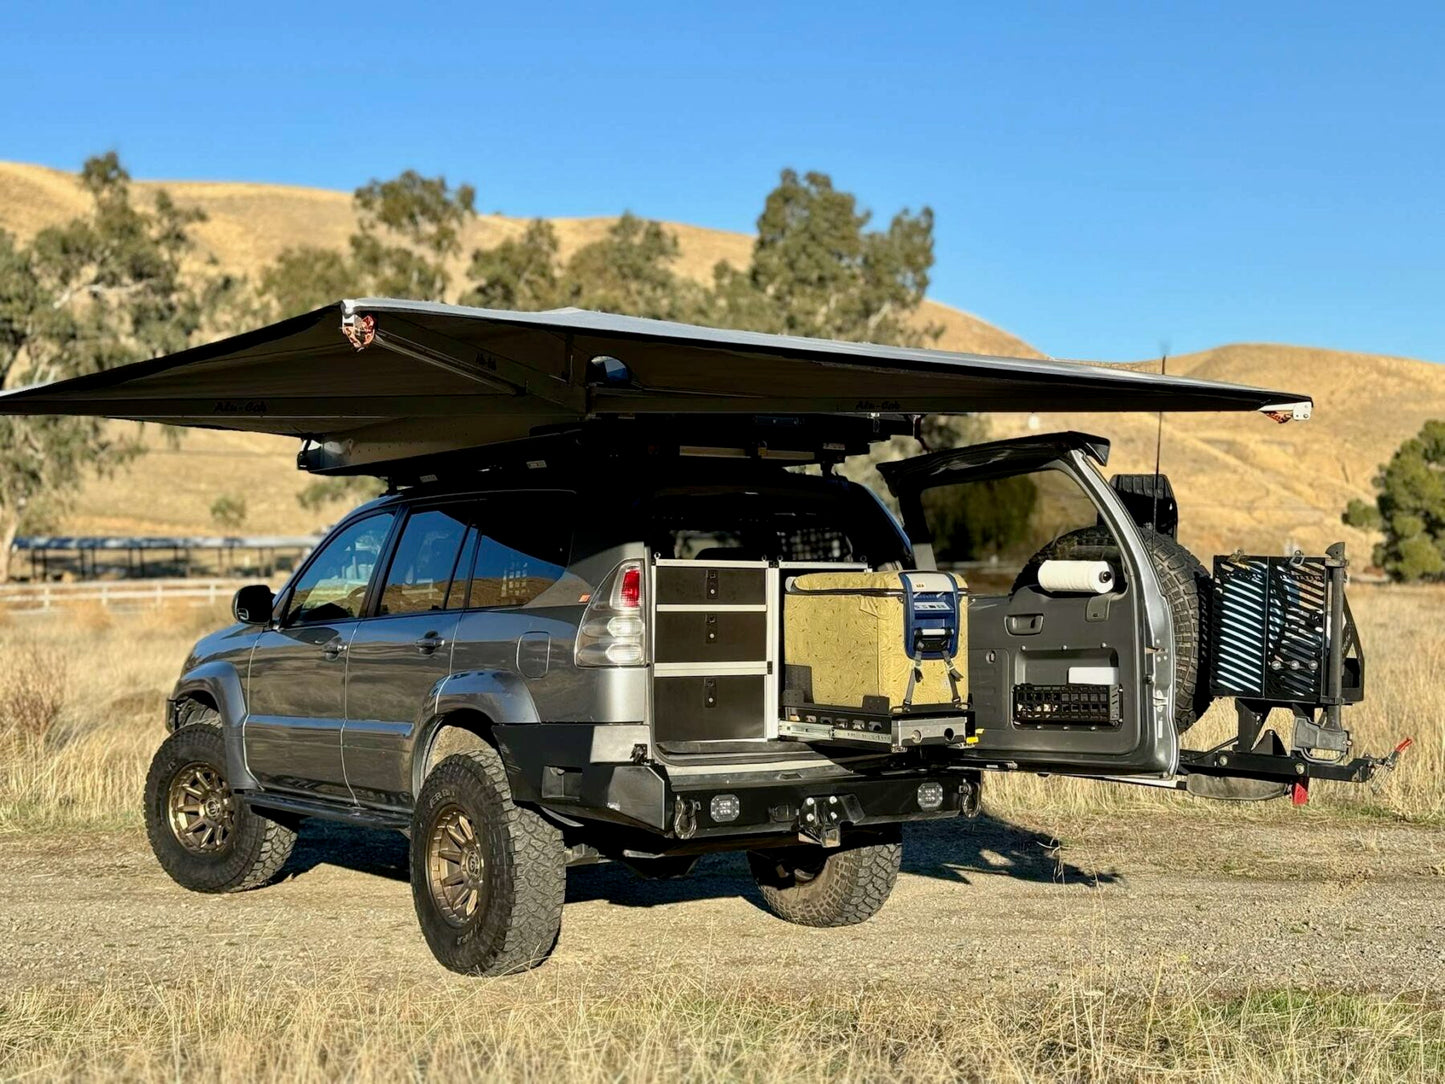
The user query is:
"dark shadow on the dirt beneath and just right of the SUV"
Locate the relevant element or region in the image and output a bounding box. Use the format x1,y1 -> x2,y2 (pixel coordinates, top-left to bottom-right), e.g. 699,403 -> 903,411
280,815 -> 1120,908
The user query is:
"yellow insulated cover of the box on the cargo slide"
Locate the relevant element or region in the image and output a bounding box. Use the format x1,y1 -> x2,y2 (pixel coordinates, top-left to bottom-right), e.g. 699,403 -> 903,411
783,572 -> 968,711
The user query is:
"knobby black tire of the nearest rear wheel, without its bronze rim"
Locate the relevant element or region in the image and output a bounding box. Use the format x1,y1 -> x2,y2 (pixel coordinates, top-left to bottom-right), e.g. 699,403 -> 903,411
410,747 -> 566,976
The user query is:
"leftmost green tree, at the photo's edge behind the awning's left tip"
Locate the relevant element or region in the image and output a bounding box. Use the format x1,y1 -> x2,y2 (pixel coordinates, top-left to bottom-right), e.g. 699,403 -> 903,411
0,152 -> 213,580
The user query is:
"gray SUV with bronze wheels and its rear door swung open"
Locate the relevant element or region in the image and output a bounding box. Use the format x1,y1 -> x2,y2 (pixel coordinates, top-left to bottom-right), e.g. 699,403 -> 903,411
137,434 -> 1374,974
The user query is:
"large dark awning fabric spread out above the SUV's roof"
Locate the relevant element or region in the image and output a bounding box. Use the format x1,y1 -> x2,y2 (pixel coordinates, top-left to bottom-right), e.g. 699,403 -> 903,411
0,298 -> 1311,463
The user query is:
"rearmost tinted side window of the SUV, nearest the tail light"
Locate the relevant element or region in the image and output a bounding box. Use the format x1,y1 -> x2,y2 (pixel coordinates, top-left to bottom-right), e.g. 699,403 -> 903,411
458,493 -> 575,610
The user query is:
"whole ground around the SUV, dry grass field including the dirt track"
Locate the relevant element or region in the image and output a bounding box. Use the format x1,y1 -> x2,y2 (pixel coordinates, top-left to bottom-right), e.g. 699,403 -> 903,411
0,587 -> 1445,1081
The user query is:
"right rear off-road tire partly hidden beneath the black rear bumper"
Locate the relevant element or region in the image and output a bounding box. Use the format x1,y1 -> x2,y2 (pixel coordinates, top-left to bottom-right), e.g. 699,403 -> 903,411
747,831 -> 903,926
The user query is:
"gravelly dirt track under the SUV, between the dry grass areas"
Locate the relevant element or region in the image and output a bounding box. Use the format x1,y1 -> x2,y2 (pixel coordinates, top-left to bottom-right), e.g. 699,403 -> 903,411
0,809 -> 1445,993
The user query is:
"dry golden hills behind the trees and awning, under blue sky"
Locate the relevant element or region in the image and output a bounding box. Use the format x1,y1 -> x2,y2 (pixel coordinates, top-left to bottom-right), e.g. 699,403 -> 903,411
0,163 -> 1445,569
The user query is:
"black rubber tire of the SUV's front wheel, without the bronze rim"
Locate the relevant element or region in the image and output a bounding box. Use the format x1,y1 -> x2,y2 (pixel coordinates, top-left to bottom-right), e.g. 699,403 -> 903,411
146,725 -> 296,892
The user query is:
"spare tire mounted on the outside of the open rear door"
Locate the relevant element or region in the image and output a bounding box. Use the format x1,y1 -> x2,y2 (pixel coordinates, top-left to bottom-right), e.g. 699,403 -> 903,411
1013,526 -> 1214,734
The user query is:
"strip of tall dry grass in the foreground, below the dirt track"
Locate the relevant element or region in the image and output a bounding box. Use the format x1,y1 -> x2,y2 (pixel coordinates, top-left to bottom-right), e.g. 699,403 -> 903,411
0,961 -> 1445,1084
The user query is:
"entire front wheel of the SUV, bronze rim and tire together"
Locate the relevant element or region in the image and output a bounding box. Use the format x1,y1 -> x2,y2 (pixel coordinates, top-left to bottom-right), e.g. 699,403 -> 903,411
146,725 -> 296,892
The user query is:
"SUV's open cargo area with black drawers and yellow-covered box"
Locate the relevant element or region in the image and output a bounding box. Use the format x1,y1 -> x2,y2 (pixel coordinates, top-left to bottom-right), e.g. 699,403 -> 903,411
652,559 -> 968,754
